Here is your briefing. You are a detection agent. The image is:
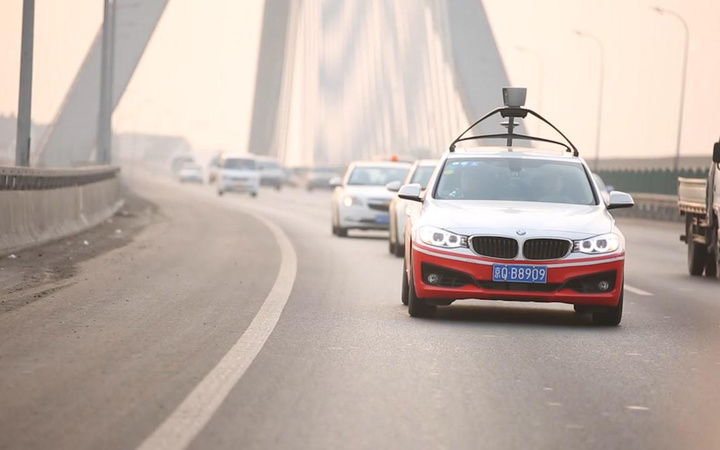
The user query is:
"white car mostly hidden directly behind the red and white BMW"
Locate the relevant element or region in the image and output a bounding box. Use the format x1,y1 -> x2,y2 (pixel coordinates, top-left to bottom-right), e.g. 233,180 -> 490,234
387,159 -> 438,257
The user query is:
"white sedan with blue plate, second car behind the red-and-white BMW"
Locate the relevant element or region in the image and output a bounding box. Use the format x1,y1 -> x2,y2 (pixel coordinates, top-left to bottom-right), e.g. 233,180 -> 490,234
330,162 -> 410,237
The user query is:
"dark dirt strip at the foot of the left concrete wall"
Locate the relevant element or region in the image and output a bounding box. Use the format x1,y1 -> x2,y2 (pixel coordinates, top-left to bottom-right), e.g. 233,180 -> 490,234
0,189 -> 160,314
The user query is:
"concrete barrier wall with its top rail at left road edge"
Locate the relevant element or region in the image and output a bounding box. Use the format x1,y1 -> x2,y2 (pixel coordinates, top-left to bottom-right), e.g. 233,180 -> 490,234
0,167 -> 122,255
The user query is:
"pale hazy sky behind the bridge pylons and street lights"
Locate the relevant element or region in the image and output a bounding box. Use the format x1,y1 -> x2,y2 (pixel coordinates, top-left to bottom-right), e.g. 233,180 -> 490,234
0,0 -> 720,160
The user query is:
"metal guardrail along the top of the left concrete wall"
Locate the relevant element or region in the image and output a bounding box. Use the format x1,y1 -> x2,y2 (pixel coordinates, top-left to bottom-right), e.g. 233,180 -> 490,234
0,166 -> 120,191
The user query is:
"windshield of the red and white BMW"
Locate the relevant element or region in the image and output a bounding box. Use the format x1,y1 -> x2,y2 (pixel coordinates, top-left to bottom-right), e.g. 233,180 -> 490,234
435,158 -> 597,205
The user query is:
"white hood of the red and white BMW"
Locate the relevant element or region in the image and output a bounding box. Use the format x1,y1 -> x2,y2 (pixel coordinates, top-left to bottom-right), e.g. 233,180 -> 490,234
421,200 -> 614,239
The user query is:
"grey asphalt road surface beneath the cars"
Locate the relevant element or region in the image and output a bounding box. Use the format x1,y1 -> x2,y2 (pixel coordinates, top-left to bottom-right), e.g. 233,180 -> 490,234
0,172 -> 720,449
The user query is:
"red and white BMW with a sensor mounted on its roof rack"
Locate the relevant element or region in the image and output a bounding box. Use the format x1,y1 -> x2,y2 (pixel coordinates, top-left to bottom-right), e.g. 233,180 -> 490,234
398,88 -> 633,325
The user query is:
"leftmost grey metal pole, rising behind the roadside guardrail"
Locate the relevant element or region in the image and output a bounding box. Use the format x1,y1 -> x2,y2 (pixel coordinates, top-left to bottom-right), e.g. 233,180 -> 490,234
15,0 -> 35,167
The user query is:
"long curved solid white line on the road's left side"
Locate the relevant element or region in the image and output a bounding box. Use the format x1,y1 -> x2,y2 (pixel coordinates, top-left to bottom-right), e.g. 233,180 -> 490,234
138,210 -> 297,450
